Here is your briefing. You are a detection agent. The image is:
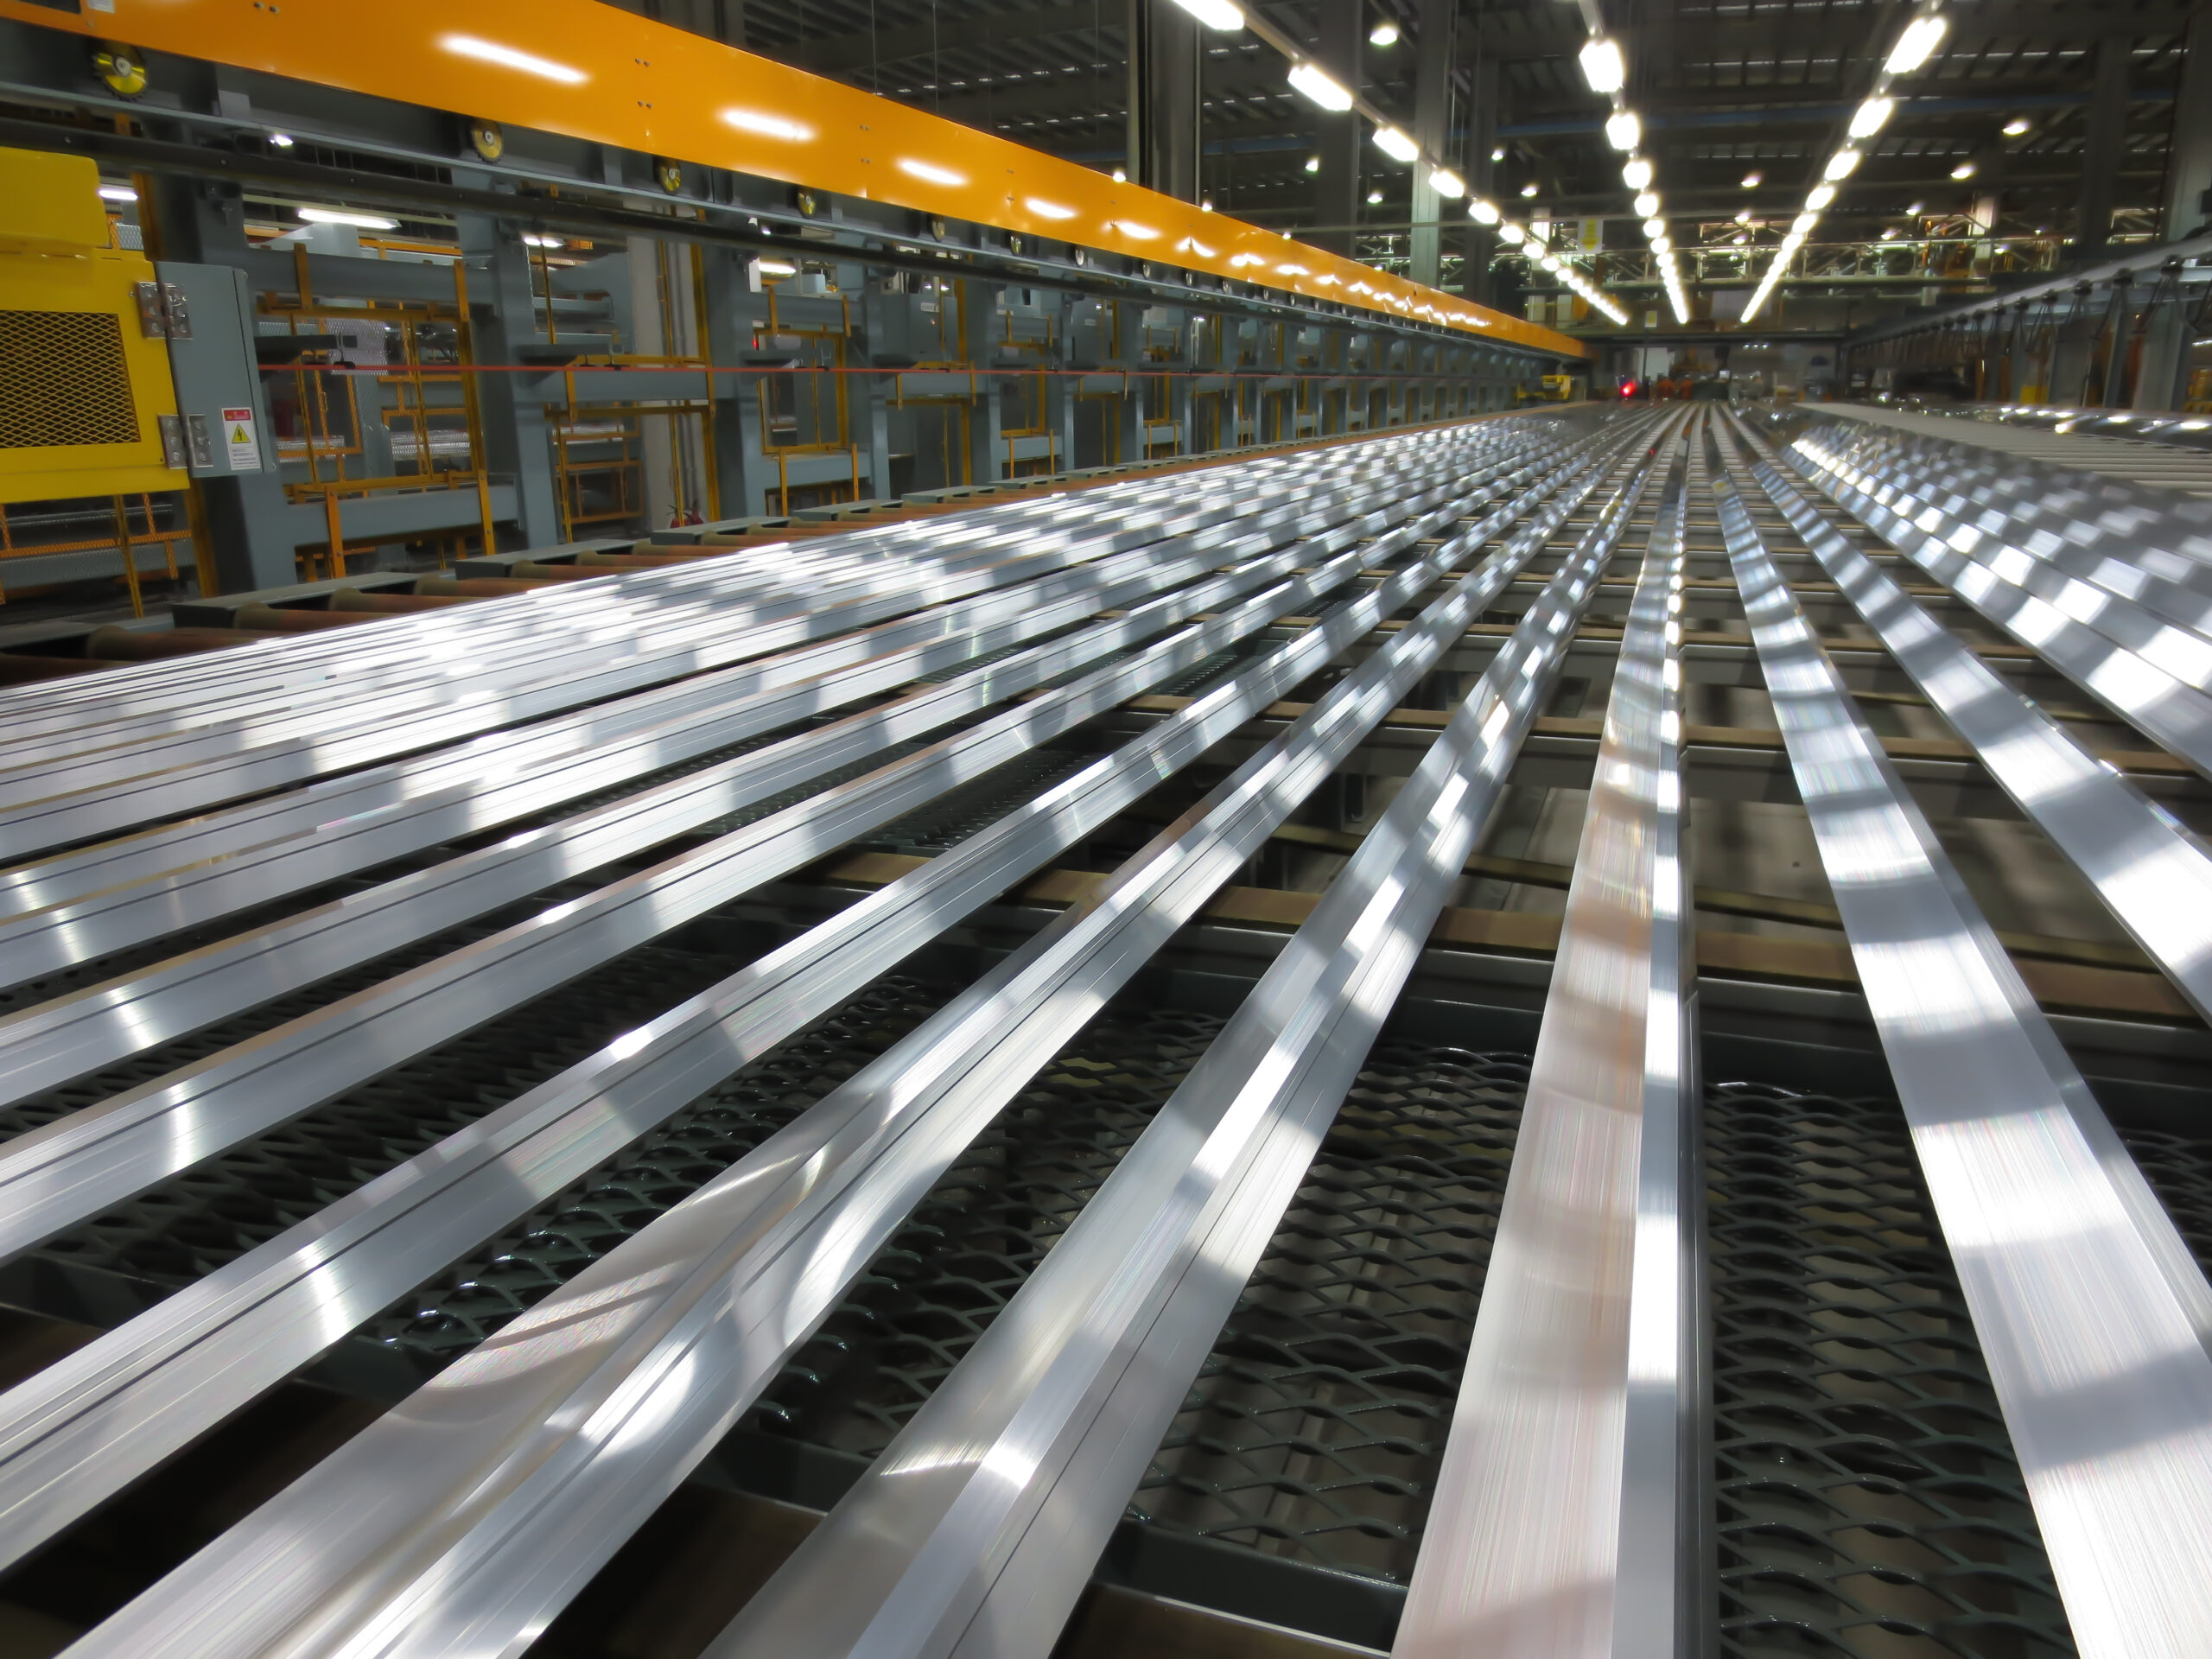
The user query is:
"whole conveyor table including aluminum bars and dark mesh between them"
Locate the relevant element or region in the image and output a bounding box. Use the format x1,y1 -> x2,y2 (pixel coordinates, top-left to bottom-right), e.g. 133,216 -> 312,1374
0,410 -> 2212,1659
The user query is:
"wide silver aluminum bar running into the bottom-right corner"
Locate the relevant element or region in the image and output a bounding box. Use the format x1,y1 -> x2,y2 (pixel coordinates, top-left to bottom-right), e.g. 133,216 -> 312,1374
1717,437 -> 2212,1659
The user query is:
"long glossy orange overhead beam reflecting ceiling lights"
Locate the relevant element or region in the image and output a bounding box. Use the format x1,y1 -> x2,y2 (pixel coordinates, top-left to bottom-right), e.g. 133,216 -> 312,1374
0,0 -> 1588,359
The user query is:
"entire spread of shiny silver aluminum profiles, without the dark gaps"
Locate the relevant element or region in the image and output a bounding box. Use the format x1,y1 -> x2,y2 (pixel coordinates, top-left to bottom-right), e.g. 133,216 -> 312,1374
0,410 -> 2212,1659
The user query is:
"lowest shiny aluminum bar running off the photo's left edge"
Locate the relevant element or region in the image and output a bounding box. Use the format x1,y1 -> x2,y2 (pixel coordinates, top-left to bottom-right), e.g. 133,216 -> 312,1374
0,422 -> 1610,1560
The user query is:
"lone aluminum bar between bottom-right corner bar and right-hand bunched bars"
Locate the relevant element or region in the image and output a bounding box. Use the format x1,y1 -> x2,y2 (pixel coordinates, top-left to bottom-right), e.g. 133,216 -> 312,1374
1717,427 -> 2212,1020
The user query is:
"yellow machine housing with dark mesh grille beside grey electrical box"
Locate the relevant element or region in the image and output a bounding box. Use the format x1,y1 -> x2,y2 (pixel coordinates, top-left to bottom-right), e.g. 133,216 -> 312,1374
0,150 -> 188,502
